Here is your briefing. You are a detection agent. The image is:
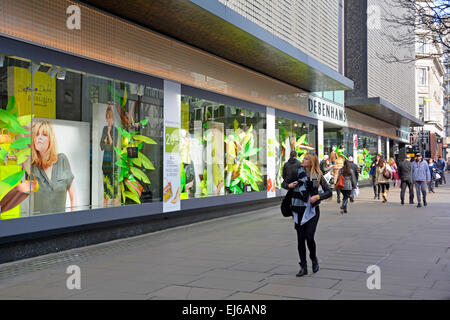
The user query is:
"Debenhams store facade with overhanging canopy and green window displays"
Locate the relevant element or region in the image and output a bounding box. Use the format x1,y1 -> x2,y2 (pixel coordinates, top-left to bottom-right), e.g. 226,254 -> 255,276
0,0 -> 422,256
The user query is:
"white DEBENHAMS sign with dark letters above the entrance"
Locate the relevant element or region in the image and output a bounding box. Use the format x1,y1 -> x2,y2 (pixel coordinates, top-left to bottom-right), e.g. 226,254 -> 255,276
308,95 -> 347,126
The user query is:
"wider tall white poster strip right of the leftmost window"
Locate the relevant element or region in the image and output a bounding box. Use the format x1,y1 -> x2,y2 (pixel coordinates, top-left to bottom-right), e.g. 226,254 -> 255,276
163,80 -> 181,212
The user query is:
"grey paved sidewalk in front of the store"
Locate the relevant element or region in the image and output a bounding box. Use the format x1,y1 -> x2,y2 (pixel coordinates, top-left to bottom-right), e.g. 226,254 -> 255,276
0,175 -> 450,300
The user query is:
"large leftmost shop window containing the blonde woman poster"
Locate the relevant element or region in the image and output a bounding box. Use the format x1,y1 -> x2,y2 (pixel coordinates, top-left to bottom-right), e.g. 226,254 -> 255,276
0,52 -> 163,219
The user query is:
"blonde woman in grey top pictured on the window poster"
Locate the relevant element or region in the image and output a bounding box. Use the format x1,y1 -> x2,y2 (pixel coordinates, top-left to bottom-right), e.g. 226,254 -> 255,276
24,120 -> 76,214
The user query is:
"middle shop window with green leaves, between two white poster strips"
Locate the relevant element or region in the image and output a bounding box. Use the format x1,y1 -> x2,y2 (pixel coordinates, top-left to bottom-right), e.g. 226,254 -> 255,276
180,96 -> 267,200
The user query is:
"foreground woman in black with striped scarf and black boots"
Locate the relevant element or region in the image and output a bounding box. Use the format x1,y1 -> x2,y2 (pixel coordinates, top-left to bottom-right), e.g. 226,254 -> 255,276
288,152 -> 332,277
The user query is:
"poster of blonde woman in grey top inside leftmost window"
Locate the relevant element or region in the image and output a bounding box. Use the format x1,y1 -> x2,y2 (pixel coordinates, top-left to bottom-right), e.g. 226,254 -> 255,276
31,118 -> 91,215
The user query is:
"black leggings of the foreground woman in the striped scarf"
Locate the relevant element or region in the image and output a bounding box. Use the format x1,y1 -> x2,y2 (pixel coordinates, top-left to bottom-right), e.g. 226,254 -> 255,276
295,206 -> 320,267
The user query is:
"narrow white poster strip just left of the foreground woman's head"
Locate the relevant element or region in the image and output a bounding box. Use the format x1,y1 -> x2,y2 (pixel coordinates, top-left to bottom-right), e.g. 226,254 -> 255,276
266,107 -> 276,198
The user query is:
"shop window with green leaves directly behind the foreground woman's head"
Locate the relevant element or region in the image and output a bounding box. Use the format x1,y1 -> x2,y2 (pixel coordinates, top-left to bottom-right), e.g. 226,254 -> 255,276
275,117 -> 317,188
